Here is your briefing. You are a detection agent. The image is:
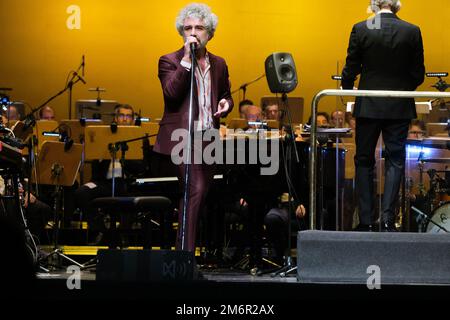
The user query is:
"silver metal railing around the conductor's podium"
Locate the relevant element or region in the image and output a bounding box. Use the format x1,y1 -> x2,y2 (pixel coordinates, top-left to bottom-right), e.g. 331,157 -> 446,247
308,89 -> 450,230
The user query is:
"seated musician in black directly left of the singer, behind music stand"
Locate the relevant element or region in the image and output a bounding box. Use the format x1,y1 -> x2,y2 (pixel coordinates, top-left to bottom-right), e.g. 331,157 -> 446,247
74,104 -> 150,244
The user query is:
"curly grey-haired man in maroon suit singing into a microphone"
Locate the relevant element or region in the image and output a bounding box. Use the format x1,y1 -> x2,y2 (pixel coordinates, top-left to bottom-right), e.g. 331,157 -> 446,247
154,4 -> 233,251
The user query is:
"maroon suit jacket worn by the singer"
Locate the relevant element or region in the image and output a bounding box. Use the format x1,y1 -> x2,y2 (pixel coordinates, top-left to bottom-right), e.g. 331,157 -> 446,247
153,48 -> 233,155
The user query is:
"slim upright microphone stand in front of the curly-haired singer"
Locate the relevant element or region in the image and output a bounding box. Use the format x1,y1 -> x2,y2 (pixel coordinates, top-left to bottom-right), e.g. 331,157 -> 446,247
180,46 -> 197,251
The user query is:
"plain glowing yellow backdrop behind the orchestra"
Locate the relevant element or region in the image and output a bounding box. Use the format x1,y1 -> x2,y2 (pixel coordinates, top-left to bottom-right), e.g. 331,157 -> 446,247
0,0 -> 450,119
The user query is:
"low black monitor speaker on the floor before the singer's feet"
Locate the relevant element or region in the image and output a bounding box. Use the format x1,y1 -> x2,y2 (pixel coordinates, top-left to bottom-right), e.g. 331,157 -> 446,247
96,249 -> 197,282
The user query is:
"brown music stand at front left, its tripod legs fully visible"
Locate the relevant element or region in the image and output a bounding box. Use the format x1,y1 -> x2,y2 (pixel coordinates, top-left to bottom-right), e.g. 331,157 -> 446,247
36,141 -> 83,268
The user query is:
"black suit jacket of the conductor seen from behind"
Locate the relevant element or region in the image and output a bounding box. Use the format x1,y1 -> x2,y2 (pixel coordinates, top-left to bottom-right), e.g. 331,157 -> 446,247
342,13 -> 425,119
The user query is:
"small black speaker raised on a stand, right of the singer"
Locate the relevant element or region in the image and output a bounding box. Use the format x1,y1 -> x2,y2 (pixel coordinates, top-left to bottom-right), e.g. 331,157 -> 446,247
265,52 -> 298,93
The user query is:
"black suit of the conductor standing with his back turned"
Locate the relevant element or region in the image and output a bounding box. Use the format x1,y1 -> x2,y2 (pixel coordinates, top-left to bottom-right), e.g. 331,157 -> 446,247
342,8 -> 425,231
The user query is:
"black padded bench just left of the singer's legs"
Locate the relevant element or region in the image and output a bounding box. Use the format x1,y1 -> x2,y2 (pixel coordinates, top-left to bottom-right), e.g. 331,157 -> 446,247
92,196 -> 172,249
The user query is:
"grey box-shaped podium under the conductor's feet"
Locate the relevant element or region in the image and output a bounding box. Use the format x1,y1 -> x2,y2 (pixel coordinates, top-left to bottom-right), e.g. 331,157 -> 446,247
297,231 -> 450,285
